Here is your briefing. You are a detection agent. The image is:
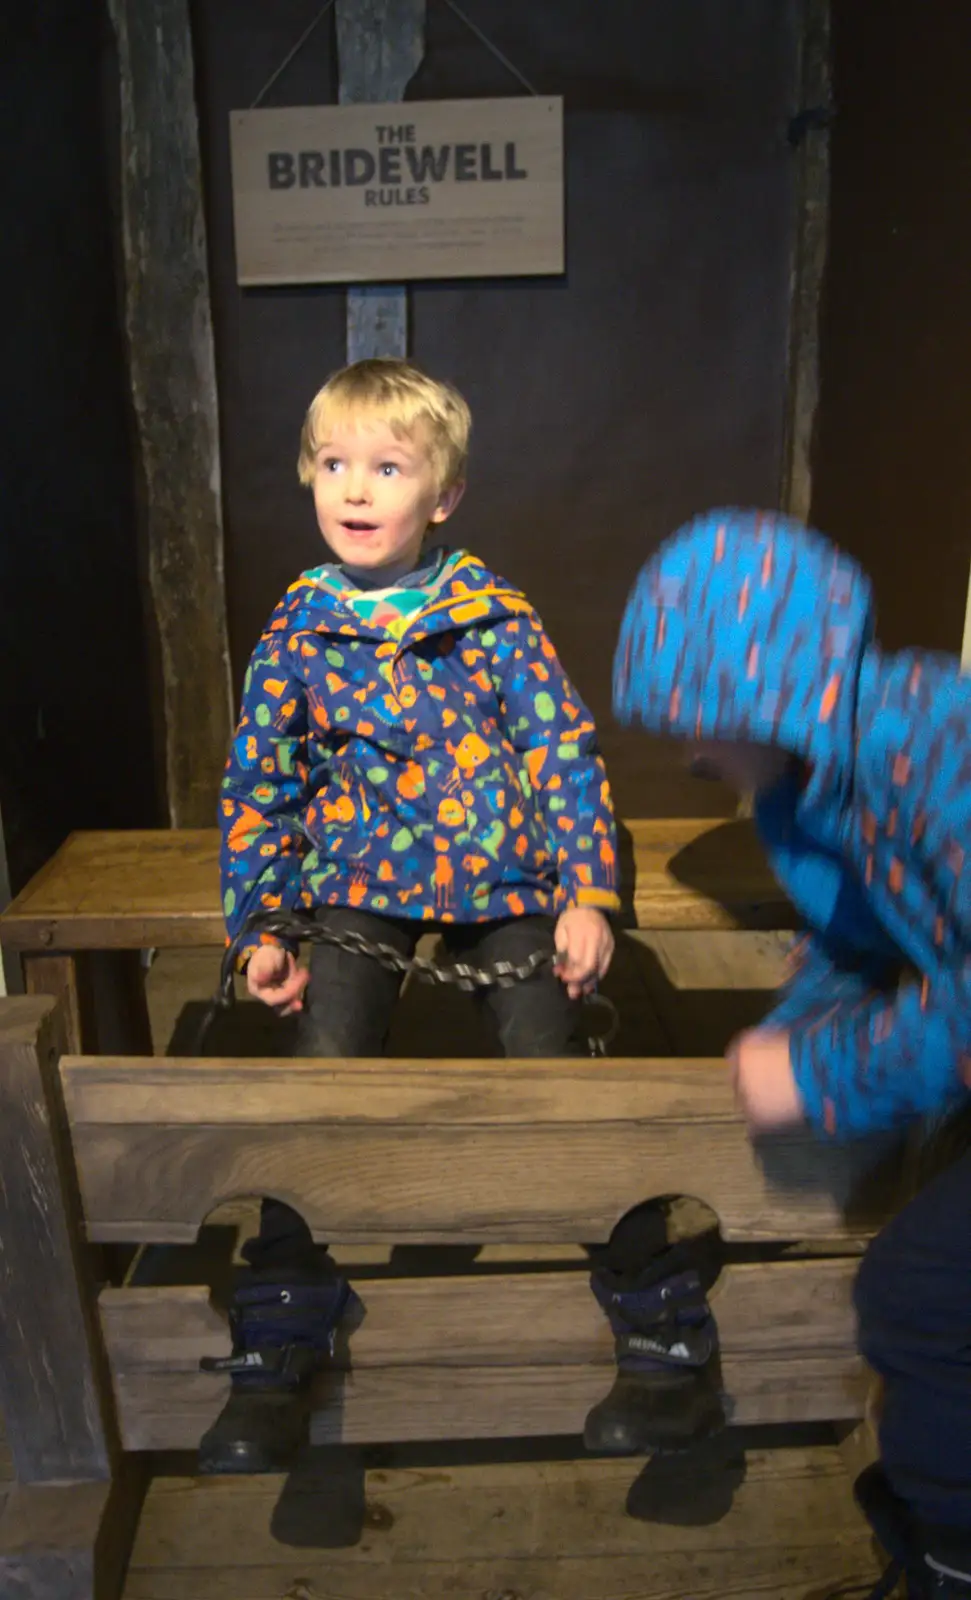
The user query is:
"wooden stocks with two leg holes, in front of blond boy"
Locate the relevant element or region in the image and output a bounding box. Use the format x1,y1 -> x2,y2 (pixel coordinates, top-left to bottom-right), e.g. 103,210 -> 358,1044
0,997 -> 899,1600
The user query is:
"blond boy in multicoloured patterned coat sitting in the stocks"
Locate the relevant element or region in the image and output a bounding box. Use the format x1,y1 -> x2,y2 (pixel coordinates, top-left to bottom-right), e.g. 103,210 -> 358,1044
202,360 -> 619,1472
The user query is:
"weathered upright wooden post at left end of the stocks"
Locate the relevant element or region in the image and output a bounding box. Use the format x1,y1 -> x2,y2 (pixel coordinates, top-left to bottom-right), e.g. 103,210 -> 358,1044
0,998 -> 112,1483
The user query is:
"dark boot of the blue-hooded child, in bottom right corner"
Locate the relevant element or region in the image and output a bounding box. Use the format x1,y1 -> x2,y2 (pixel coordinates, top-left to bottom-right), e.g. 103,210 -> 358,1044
853,1461 -> 971,1600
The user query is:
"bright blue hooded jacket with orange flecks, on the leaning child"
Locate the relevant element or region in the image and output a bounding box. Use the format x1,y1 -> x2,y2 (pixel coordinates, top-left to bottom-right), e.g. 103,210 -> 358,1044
614,510 -> 971,1136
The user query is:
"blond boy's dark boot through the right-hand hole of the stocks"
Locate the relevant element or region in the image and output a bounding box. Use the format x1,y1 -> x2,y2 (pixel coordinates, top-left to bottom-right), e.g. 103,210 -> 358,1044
584,1245 -> 725,1456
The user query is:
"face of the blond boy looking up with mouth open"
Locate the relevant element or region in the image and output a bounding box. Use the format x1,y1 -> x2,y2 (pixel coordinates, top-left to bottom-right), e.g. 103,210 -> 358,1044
314,418 -> 464,571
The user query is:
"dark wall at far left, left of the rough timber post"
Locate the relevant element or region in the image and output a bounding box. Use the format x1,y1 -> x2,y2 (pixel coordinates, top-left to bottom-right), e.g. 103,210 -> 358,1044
0,0 -> 157,890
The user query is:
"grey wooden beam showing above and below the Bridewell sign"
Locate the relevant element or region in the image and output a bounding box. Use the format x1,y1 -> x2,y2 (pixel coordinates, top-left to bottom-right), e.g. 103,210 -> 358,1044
336,0 -> 426,362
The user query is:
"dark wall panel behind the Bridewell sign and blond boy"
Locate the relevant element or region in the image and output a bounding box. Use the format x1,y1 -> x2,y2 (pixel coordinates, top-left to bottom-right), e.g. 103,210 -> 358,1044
195,0 -> 798,814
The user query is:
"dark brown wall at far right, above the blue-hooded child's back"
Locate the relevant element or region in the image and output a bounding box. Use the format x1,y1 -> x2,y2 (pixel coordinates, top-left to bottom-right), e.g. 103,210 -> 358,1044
813,0 -> 971,651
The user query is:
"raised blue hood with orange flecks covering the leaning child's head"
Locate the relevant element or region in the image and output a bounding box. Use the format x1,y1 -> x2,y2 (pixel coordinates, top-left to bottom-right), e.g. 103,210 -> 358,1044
614,510 -> 873,792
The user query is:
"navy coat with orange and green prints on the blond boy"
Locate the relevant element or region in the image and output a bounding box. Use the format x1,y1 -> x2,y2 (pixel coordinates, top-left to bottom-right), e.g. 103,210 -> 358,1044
221,550 -> 619,962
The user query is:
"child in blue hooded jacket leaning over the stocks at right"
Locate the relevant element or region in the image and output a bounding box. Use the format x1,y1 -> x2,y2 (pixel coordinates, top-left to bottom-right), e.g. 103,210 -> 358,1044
614,510 -> 971,1600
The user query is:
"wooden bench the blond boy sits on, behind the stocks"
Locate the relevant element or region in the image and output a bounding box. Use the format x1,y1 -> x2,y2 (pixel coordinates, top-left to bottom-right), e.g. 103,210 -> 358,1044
0,818 -> 795,1053
